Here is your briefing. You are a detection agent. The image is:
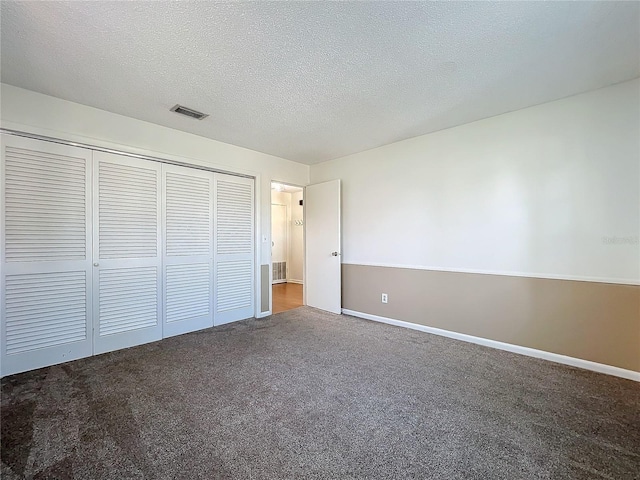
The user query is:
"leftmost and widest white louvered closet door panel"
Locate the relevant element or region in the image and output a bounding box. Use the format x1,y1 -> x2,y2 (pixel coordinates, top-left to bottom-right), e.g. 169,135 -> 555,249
0,135 -> 92,375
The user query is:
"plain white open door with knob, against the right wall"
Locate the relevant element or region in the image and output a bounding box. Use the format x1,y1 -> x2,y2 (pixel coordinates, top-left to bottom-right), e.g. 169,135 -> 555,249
304,180 -> 342,313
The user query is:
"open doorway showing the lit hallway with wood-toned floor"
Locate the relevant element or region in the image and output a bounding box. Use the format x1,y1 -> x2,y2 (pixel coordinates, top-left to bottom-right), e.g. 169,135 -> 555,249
271,182 -> 304,313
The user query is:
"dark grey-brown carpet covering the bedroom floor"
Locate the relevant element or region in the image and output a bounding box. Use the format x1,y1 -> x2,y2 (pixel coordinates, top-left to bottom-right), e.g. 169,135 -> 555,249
1,307 -> 640,480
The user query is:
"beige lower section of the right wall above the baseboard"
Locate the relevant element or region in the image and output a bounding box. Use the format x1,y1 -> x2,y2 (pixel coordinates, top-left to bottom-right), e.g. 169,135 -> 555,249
342,264 -> 640,372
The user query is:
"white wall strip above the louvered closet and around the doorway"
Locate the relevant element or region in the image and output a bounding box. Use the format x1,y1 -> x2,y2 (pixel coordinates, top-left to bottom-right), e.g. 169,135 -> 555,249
0,84 -> 309,312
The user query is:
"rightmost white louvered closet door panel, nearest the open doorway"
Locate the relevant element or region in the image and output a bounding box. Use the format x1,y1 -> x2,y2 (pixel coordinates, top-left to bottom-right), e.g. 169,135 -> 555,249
213,173 -> 254,325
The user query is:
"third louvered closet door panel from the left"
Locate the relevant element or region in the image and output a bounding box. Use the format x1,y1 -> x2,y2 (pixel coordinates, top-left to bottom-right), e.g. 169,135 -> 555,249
162,165 -> 213,337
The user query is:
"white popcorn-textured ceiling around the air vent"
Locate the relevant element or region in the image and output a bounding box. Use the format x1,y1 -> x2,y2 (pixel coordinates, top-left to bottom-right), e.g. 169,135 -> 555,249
0,1 -> 640,164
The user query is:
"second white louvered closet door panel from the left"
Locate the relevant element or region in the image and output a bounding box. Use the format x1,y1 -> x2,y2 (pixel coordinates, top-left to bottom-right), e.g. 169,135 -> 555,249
93,152 -> 162,354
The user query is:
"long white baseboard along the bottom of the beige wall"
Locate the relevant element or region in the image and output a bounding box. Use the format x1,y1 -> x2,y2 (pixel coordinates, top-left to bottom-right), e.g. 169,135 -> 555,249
342,308 -> 640,382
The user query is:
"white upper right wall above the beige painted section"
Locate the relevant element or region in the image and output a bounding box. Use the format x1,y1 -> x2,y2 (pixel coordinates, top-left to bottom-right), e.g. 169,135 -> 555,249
311,79 -> 640,283
